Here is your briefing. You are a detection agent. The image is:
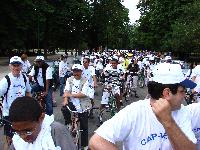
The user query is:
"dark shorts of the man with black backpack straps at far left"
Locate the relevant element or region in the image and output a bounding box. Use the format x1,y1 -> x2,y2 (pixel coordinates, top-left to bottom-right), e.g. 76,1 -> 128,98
3,116 -> 14,138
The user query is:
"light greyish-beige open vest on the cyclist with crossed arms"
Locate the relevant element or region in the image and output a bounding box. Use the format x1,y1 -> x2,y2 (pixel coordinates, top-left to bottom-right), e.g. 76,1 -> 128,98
68,76 -> 92,110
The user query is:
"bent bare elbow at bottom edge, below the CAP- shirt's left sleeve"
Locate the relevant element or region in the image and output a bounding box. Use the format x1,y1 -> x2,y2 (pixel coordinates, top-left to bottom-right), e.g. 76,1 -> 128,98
89,133 -> 118,150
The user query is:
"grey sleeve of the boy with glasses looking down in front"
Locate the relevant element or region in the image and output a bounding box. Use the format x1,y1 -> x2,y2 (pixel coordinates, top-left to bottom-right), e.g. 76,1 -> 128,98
51,122 -> 76,150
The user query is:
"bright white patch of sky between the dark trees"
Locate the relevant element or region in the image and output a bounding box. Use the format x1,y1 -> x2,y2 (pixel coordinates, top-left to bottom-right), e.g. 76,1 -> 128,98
122,0 -> 140,23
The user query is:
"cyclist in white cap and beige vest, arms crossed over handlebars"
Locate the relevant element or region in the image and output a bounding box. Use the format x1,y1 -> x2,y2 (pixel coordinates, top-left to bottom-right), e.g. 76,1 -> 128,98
62,64 -> 92,149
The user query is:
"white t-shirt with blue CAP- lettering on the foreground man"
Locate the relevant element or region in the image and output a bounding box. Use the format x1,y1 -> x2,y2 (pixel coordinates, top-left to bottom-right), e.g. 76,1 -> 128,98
95,99 -> 196,150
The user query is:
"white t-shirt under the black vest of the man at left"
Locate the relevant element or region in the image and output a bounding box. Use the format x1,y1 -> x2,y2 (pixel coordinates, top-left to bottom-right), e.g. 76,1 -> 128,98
29,67 -> 53,86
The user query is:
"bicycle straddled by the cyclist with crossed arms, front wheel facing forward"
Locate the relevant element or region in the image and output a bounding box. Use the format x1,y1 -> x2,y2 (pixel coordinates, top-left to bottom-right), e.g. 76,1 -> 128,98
66,105 -> 91,150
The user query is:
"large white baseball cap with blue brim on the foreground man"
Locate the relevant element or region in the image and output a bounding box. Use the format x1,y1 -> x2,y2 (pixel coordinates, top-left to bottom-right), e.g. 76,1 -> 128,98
153,63 -> 197,89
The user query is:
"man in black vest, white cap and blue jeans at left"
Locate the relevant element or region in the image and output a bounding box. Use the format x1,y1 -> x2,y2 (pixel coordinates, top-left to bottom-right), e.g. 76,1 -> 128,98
29,56 -> 53,116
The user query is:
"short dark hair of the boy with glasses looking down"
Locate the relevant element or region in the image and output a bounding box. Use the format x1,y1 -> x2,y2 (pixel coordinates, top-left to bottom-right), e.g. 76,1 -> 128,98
9,96 -> 42,122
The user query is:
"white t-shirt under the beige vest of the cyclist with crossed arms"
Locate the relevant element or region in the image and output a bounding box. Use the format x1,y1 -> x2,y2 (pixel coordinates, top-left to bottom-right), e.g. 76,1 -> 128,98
64,78 -> 91,112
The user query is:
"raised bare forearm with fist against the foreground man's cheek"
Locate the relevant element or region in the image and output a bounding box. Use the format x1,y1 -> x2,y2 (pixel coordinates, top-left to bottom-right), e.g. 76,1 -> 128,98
151,98 -> 196,150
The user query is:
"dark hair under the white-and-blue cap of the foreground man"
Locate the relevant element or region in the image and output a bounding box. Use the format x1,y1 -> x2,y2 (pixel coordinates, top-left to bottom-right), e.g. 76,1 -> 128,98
148,81 -> 181,99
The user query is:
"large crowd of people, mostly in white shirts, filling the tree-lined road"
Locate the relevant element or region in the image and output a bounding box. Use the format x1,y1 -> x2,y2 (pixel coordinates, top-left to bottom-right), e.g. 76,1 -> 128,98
0,50 -> 200,150
